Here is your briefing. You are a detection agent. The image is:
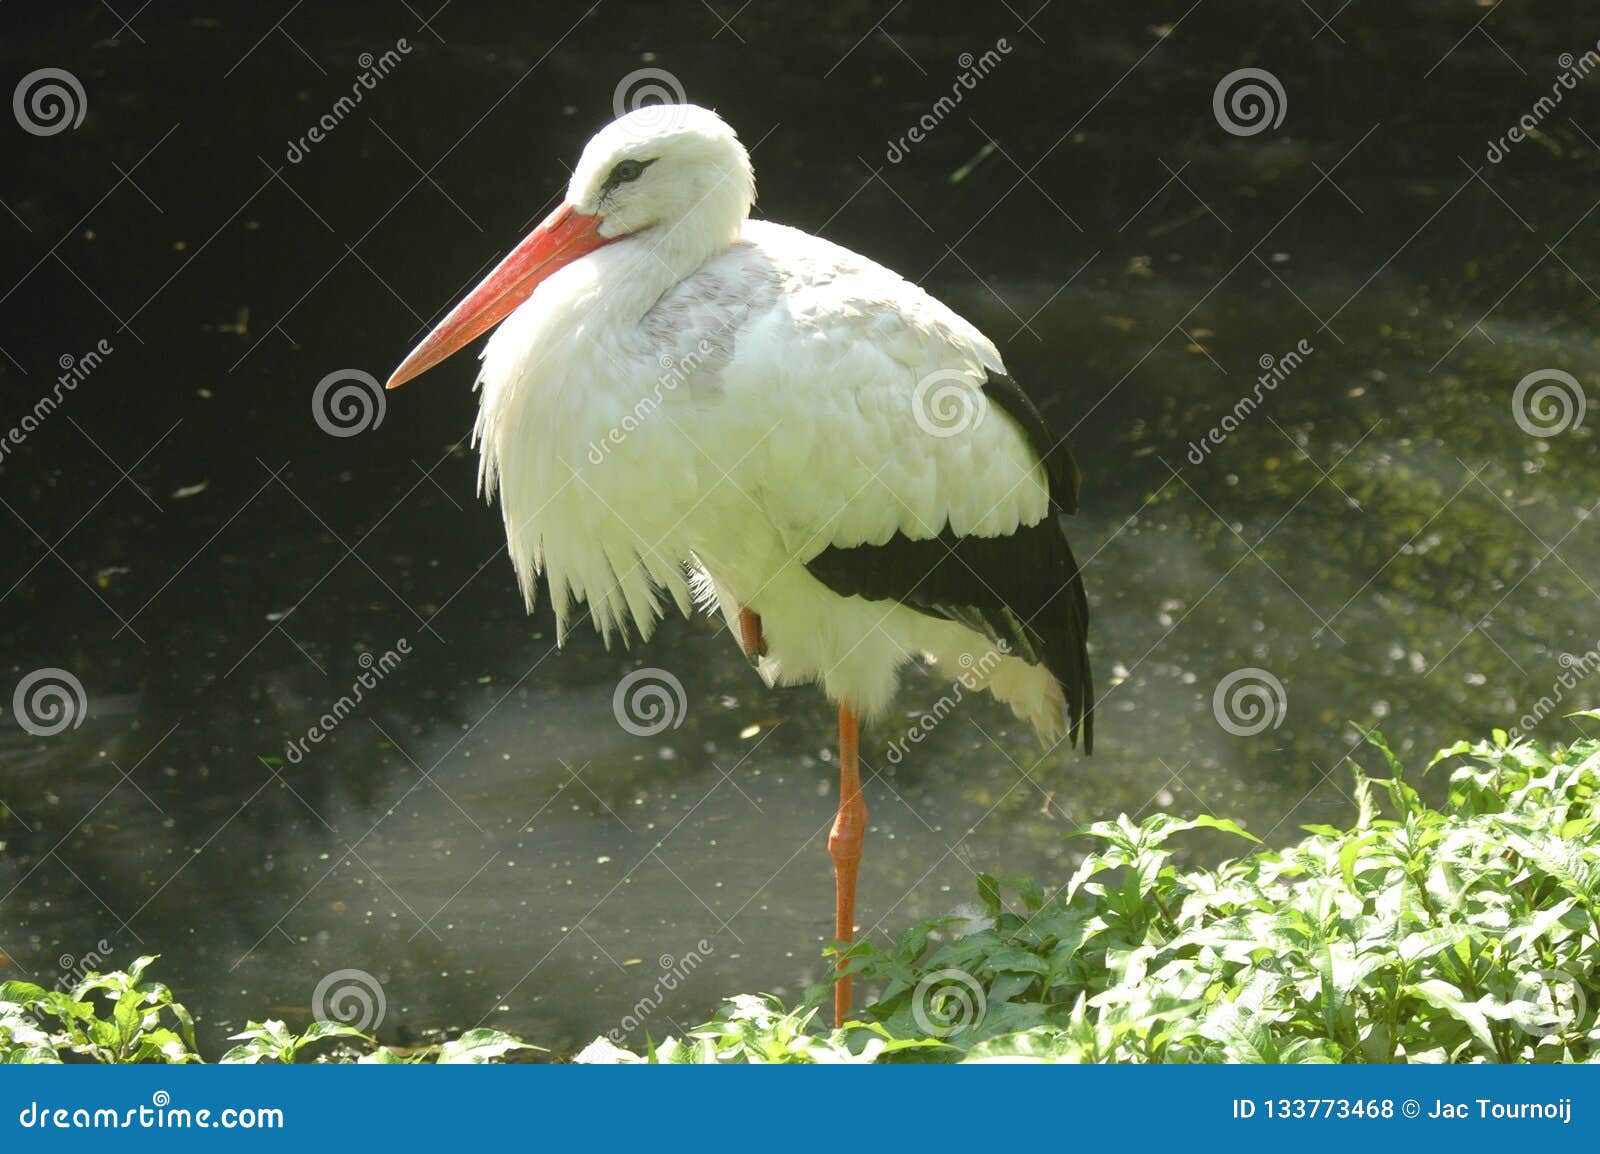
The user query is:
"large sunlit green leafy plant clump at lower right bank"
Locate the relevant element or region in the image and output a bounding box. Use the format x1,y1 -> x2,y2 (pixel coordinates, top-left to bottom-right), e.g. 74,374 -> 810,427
589,720 -> 1600,1063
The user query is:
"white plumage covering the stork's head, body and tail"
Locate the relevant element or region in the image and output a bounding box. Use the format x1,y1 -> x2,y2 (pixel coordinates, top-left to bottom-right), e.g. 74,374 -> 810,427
475,106 -> 1062,738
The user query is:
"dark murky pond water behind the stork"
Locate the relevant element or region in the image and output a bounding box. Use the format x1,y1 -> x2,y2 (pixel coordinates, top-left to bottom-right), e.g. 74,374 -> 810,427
0,3 -> 1600,1052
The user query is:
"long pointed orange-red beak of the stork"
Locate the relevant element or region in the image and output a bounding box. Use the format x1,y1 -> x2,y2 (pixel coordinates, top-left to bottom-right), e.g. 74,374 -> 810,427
384,205 -> 618,389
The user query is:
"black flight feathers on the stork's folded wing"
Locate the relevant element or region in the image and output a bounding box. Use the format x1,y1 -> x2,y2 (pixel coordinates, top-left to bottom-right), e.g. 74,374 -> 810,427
806,373 -> 1094,752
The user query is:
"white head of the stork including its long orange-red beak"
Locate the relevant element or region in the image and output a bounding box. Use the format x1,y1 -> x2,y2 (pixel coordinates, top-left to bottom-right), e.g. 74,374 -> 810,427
387,104 -> 755,389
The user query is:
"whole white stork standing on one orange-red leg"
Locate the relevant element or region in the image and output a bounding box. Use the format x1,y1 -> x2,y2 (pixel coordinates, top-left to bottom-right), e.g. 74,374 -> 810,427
389,104 -> 1093,1024
